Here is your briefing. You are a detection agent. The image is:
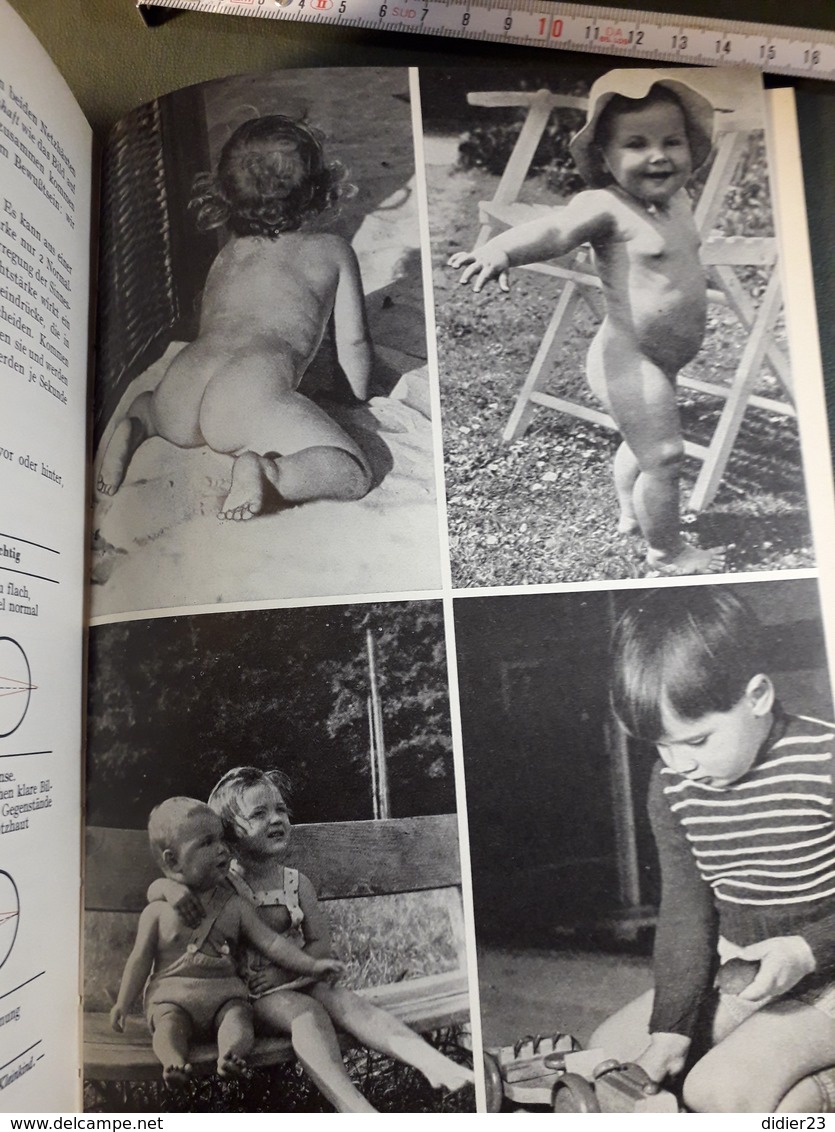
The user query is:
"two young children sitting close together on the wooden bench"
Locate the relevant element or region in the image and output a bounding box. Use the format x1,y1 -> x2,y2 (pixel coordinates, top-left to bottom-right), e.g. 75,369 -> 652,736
112,766 -> 473,1113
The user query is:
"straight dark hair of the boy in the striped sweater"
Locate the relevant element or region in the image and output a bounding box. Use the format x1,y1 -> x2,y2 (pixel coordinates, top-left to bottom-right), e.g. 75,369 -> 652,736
611,585 -> 764,743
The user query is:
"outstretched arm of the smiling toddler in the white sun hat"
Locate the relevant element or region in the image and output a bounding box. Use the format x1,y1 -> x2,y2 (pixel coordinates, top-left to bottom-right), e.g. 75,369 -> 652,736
449,190 -> 614,292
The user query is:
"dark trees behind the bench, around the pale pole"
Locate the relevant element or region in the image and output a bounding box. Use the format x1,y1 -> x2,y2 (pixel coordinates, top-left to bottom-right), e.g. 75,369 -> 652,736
87,602 -> 455,827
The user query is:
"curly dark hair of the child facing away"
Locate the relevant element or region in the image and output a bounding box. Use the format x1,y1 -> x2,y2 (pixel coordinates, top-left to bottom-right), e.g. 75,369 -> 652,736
189,114 -> 345,239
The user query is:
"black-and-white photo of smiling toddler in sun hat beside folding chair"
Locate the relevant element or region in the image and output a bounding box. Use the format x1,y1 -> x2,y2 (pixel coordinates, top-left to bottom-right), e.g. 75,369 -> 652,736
421,59 -> 814,588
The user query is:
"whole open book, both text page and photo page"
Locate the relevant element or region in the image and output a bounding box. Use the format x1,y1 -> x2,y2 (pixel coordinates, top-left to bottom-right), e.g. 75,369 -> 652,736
0,0 -> 835,1112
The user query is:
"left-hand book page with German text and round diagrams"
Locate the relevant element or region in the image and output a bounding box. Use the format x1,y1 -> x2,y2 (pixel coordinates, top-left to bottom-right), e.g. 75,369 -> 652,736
0,5 -> 92,1112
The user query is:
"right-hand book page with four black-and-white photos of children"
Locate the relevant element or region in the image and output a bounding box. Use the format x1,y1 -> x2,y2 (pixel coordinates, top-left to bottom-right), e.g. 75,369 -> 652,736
84,59 -> 835,1112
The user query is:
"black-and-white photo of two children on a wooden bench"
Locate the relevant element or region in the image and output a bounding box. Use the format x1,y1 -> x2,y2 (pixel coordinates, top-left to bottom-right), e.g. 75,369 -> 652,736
84,602 -> 475,1113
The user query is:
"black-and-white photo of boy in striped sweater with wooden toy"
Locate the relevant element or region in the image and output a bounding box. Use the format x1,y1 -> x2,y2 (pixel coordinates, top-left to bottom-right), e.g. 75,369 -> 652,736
455,578 -> 835,1113
